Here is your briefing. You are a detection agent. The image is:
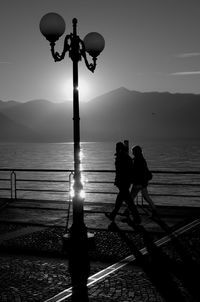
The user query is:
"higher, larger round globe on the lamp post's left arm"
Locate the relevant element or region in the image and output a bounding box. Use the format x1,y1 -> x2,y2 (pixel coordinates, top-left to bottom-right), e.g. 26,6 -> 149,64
40,13 -> 65,42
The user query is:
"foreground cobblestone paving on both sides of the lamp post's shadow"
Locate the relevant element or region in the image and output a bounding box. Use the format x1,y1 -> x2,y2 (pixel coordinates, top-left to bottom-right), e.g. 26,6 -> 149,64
0,256 -> 164,302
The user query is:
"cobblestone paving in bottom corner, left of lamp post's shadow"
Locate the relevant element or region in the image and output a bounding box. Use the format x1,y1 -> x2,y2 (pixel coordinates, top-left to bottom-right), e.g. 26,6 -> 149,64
0,255 -> 70,302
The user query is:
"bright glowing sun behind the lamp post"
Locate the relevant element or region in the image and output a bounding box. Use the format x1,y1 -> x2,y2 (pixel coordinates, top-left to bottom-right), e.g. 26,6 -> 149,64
60,77 -> 91,102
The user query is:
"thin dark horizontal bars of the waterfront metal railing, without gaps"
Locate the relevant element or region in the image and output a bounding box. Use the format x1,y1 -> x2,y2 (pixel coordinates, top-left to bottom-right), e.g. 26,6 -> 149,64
0,168 -> 200,202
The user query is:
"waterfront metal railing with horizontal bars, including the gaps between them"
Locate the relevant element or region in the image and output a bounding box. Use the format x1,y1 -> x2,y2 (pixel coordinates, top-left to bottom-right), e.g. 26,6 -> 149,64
0,169 -> 200,203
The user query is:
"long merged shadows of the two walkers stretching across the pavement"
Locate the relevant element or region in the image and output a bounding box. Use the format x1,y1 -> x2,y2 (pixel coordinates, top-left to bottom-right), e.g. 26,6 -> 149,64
110,221 -> 199,302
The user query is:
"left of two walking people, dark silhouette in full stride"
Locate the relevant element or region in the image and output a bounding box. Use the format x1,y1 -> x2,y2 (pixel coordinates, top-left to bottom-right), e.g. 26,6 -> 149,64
105,142 -> 141,224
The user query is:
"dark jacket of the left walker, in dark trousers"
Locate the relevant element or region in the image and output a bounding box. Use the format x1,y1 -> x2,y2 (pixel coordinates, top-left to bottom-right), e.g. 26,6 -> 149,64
115,152 -> 133,186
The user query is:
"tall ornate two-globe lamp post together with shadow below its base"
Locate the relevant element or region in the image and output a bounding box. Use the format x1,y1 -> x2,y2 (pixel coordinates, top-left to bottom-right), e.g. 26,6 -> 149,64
40,13 -> 105,302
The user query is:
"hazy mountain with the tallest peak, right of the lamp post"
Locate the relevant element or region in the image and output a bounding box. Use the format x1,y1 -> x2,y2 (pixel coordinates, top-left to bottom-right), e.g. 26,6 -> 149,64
83,88 -> 200,140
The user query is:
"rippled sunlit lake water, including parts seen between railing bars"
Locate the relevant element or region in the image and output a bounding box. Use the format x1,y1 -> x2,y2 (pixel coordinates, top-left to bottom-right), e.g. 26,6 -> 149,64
0,141 -> 200,205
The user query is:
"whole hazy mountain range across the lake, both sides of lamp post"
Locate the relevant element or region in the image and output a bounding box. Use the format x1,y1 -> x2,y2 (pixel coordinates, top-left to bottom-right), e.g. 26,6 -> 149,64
0,87 -> 200,142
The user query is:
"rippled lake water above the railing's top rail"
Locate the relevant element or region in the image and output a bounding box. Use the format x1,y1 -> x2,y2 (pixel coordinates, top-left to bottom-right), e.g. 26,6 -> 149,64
0,141 -> 200,171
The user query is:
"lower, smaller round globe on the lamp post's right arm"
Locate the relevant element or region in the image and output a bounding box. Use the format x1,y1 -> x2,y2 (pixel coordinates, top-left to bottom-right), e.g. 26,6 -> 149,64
83,32 -> 105,58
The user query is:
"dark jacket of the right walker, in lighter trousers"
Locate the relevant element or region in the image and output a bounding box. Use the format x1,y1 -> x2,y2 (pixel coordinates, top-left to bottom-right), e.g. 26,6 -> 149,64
132,154 -> 151,187
